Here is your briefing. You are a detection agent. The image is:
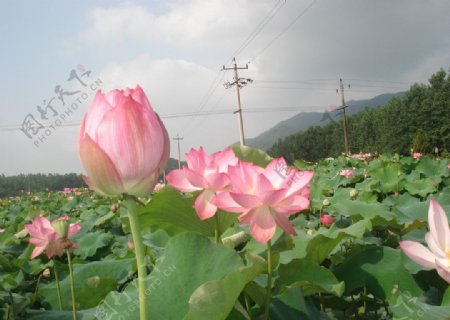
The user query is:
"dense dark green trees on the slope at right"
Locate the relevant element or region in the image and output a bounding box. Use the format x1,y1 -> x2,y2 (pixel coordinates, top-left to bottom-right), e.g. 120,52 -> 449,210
268,69 -> 450,163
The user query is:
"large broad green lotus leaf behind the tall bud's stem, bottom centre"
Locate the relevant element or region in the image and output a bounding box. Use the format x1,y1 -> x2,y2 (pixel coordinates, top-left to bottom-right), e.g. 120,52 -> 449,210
96,233 -> 265,320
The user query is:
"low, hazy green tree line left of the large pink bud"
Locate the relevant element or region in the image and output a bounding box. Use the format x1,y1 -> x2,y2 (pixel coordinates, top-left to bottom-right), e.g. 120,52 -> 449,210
0,173 -> 86,198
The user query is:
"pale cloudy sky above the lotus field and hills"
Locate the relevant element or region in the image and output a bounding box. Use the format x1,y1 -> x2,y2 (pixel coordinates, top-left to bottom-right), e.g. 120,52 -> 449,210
0,0 -> 450,175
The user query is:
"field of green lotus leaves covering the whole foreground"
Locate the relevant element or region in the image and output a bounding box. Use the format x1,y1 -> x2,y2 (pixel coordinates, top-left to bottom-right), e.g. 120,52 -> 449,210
0,151 -> 450,320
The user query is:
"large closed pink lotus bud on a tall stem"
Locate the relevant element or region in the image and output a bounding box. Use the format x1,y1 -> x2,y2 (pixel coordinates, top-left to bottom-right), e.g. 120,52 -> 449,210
78,86 -> 169,196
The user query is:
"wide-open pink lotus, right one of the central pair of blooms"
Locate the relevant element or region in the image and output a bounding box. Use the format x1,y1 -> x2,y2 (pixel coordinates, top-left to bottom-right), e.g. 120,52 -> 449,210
214,158 -> 314,243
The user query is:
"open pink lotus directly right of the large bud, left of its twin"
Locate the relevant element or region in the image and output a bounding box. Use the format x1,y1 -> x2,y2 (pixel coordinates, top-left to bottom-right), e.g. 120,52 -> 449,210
167,147 -> 239,220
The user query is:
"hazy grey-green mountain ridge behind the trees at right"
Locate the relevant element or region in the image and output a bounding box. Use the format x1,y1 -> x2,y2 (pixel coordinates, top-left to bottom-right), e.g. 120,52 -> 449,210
245,92 -> 404,150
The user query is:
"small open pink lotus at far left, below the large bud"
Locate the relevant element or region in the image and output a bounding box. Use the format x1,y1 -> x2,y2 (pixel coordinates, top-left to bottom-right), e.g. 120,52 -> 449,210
24,215 -> 81,259
